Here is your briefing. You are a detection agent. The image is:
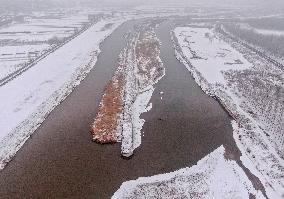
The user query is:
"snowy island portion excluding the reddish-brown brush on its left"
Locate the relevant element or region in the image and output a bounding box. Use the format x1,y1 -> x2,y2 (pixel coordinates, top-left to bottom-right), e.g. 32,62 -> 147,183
121,24 -> 165,157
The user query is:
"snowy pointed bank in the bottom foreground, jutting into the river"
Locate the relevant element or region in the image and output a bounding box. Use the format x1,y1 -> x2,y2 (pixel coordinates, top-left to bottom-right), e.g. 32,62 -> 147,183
112,146 -> 264,199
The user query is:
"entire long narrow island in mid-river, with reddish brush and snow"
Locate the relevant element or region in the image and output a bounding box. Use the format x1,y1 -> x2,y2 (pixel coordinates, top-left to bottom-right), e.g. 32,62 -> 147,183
92,20 -> 165,156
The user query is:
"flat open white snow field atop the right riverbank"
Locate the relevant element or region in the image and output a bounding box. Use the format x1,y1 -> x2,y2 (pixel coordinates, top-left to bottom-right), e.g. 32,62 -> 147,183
174,27 -> 252,83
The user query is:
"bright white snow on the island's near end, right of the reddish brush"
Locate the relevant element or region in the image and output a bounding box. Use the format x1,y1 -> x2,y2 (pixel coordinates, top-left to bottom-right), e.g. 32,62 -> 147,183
121,45 -> 155,157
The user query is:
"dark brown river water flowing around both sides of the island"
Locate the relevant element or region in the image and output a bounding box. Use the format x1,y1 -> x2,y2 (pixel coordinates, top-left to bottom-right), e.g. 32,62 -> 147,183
0,17 -> 236,199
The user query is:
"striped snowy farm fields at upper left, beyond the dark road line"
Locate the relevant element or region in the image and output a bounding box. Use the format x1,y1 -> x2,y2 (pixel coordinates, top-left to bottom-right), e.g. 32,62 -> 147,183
0,11 -> 95,80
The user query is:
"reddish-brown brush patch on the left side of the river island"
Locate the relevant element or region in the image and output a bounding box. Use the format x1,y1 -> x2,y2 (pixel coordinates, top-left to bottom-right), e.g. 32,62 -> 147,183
92,76 -> 123,144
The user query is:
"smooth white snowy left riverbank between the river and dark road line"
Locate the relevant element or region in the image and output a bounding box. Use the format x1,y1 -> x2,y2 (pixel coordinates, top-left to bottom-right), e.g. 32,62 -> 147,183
0,18 -> 125,168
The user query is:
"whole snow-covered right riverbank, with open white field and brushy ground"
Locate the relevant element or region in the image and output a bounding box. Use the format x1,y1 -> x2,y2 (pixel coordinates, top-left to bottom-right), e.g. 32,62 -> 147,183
173,27 -> 284,198
